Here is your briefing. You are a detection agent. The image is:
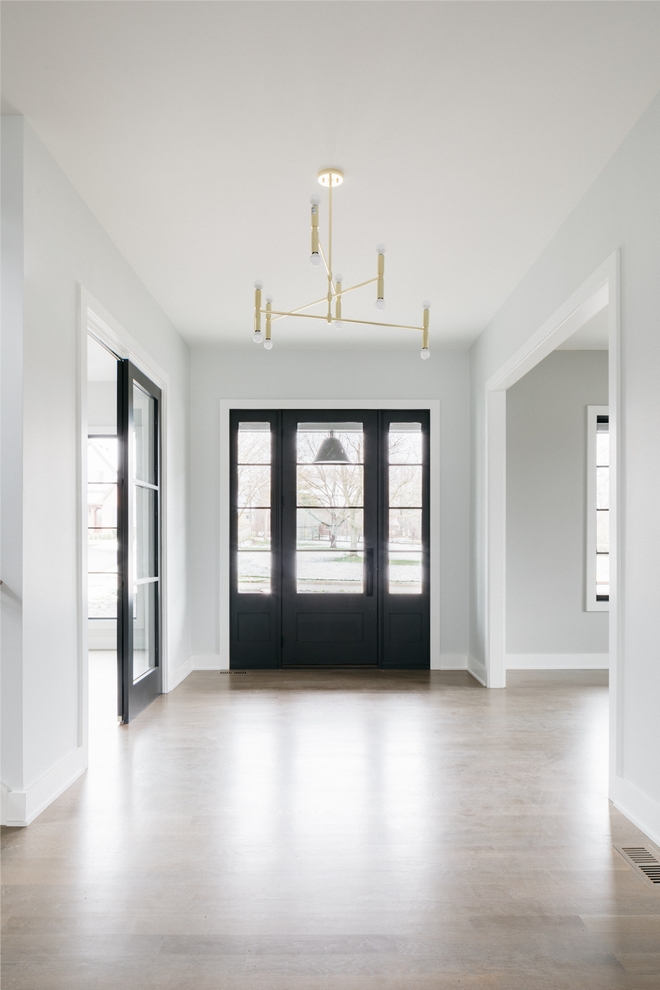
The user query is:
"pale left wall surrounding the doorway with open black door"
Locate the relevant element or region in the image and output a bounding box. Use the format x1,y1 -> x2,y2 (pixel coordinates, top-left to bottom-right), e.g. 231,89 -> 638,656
2,117 -> 190,824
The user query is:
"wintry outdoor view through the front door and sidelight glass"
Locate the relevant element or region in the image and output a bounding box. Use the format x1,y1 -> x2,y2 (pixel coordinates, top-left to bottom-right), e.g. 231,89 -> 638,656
237,422 -> 422,594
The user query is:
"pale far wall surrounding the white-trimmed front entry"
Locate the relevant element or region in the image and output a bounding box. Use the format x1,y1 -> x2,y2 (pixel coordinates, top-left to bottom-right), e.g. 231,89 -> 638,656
191,343 -> 469,664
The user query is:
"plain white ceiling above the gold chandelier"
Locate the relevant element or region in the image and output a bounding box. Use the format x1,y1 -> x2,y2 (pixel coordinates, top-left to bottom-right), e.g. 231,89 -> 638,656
2,0 -> 660,346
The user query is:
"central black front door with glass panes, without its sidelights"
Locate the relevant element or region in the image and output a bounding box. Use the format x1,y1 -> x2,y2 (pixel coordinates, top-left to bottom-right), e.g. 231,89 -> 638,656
282,410 -> 378,667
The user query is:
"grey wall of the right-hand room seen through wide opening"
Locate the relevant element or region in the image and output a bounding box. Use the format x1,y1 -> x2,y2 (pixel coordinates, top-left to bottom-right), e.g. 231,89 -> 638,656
506,350 -> 608,667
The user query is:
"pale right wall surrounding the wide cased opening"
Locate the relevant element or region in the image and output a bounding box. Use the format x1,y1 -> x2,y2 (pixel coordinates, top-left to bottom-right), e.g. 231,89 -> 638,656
471,91 -> 660,841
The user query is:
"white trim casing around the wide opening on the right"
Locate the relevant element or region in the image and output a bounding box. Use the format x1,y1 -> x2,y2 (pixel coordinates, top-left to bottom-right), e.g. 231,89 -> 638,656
482,252 -> 621,697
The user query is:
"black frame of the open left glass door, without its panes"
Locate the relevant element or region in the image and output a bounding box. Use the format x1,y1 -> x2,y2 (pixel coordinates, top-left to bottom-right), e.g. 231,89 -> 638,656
117,359 -> 163,723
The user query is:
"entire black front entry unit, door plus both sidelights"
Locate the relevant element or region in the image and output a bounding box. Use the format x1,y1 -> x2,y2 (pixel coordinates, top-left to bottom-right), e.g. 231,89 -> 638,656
231,409 -> 430,668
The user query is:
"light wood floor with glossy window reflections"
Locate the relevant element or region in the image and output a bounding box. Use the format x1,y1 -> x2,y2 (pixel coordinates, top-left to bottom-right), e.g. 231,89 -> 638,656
2,664 -> 660,990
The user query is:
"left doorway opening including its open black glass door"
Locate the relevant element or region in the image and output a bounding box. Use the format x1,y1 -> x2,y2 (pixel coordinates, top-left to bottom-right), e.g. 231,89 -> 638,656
86,334 -> 162,729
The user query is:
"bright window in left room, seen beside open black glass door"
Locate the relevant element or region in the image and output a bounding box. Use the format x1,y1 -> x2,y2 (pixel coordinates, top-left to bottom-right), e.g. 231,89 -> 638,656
87,437 -> 117,619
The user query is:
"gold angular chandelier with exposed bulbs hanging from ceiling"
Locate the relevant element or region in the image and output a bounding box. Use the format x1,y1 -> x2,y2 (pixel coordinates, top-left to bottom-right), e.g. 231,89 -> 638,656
253,168 -> 431,359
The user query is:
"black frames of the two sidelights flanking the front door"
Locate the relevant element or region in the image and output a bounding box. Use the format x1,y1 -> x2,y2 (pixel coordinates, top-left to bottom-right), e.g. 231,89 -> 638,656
229,403 -> 431,670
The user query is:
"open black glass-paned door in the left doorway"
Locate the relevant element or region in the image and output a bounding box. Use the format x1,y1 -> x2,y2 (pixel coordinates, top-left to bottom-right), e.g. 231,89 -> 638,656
117,360 -> 162,722
